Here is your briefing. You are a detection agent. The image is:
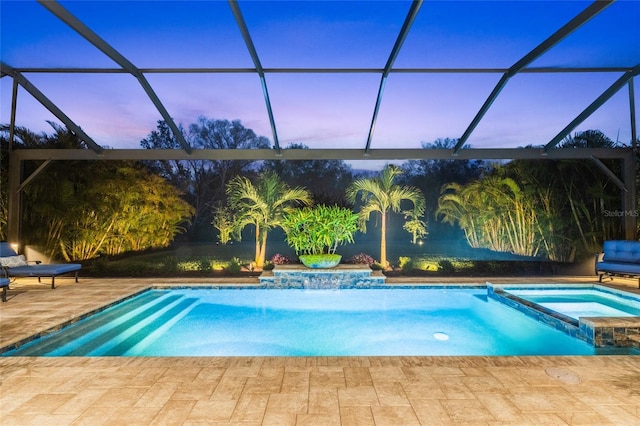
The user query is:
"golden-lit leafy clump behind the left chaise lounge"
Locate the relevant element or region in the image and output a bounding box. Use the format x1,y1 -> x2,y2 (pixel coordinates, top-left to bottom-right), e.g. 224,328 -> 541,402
48,163 -> 193,260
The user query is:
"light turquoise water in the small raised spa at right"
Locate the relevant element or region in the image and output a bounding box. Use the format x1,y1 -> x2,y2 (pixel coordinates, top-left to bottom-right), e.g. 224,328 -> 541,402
506,288 -> 640,319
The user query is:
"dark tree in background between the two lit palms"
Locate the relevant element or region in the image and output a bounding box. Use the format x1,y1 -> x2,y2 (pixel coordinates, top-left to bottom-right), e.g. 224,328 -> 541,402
262,144 -> 353,206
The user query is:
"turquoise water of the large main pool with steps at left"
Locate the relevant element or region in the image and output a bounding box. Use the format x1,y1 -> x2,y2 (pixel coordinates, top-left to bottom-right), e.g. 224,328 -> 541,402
3,289 -> 628,356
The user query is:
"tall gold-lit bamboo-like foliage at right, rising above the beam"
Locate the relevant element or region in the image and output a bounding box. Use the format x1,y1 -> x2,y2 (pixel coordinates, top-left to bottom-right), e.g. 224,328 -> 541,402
436,130 -> 626,262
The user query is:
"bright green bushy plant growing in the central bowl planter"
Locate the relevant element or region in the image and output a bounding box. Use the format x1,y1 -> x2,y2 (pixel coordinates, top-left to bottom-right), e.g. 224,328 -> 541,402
282,204 -> 358,254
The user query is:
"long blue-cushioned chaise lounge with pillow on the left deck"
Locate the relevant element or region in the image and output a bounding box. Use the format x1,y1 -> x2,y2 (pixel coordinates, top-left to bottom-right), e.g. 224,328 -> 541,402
0,243 -> 82,292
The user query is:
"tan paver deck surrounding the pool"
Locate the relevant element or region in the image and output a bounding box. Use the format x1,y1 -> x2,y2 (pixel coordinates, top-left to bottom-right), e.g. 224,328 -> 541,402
0,277 -> 640,426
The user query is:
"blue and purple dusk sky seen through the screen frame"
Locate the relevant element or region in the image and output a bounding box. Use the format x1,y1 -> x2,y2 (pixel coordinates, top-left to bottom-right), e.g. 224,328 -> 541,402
0,0 -> 640,157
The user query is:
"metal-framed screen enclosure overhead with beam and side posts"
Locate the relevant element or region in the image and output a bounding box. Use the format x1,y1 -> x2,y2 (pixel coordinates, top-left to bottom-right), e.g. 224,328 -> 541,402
0,0 -> 640,243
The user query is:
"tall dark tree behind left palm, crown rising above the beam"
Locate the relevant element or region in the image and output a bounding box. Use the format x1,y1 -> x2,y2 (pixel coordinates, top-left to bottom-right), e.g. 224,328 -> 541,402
140,117 -> 270,238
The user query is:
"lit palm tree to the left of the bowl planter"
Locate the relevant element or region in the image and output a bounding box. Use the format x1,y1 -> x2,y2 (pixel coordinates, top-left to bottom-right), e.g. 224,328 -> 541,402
226,173 -> 311,268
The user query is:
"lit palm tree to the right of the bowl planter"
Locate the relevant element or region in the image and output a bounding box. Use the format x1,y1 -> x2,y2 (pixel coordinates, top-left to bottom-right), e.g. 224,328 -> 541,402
347,165 -> 425,267
